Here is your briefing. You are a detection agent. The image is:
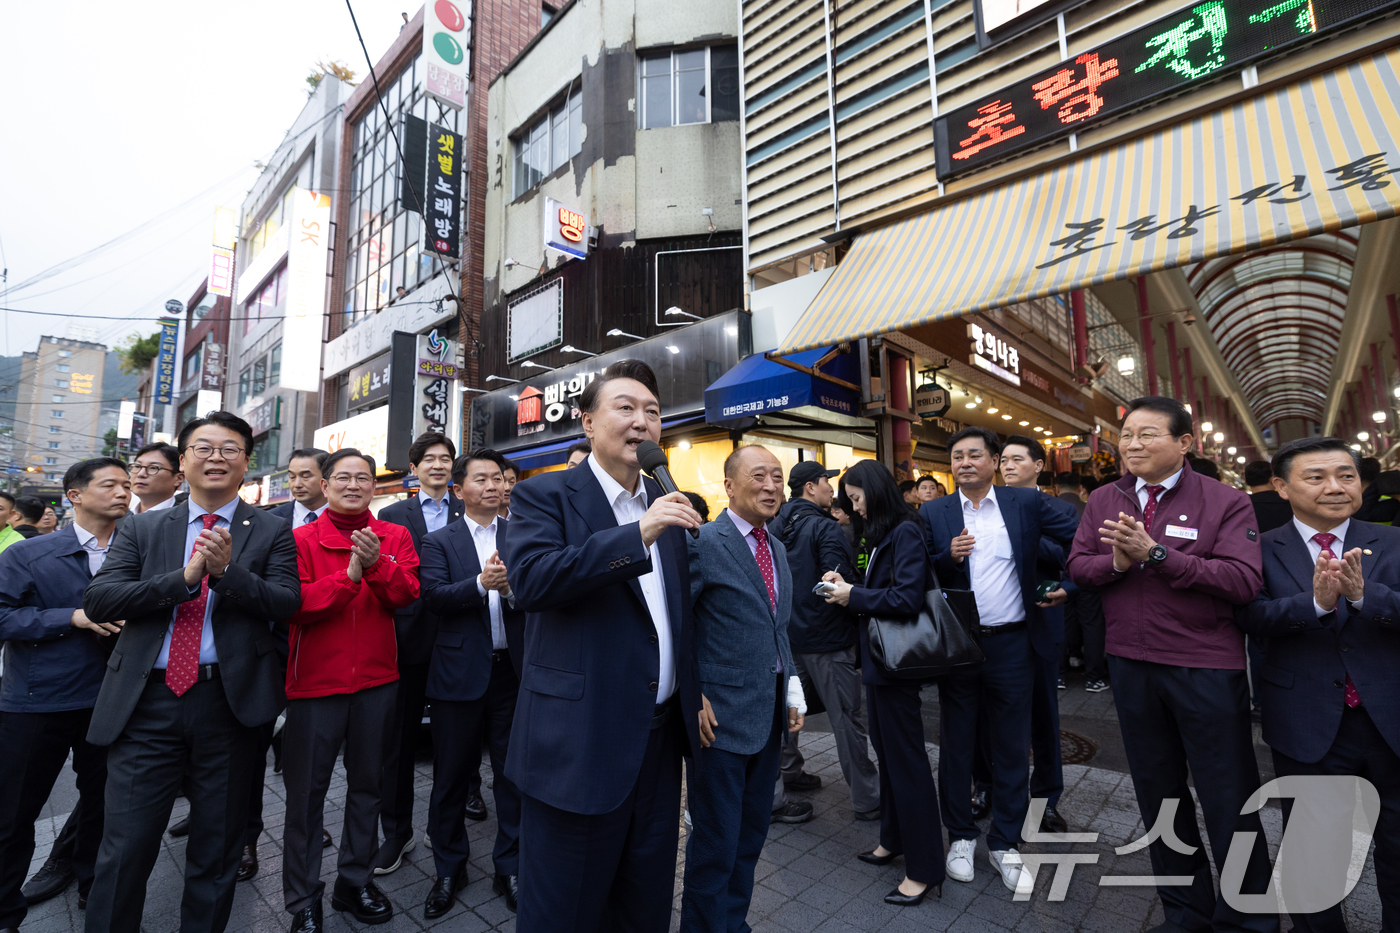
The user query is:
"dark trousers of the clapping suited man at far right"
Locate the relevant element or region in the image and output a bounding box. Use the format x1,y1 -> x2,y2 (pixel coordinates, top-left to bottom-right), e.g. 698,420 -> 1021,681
1274,706 -> 1400,933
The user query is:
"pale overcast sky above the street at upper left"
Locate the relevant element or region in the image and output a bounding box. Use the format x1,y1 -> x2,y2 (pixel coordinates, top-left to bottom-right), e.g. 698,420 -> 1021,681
0,0 -> 408,356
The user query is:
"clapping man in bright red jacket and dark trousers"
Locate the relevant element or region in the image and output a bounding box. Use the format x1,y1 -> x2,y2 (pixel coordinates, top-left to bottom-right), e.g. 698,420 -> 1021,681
281,447 -> 419,933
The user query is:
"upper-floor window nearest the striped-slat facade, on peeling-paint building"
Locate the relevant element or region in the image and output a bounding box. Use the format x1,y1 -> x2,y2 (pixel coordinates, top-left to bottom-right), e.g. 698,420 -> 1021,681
638,45 -> 739,129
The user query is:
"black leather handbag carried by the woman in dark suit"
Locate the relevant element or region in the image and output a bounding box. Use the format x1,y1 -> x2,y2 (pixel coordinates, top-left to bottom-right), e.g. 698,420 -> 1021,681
867,554 -> 983,681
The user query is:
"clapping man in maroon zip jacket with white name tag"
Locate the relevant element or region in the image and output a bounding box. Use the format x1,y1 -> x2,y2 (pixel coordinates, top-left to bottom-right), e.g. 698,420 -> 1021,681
1070,395 -> 1278,933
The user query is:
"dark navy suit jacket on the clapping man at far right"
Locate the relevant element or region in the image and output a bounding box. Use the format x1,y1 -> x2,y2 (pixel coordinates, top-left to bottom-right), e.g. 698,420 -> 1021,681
1235,518 -> 1400,763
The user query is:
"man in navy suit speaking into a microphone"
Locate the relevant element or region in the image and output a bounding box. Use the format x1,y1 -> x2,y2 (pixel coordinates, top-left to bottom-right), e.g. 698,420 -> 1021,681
501,360 -> 700,933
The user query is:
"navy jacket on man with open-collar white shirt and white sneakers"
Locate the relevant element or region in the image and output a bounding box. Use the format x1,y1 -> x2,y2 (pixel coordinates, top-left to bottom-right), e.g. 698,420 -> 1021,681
920,486 -> 1079,661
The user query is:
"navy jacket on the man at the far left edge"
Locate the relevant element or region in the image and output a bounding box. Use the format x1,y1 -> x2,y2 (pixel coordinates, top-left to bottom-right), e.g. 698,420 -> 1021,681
0,525 -> 109,713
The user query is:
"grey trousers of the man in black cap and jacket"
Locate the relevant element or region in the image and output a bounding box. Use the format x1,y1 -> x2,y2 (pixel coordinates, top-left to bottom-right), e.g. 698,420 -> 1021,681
773,646 -> 879,813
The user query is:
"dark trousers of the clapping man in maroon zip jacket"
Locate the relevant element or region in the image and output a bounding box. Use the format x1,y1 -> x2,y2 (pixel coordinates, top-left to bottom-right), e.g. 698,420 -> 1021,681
1109,654 -> 1278,933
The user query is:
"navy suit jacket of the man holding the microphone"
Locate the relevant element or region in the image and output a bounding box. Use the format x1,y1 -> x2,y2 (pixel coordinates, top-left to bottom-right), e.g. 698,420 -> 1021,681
501,464 -> 700,815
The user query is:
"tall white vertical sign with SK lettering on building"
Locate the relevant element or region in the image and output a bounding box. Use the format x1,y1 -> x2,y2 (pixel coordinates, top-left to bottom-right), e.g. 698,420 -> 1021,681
281,188 -> 330,392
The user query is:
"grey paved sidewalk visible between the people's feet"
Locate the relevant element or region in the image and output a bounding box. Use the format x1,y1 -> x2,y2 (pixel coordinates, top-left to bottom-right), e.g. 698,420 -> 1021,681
22,706 -> 1380,933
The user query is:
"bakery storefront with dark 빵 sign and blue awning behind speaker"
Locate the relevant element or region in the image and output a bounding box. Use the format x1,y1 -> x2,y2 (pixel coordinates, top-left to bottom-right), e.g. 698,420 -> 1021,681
469,310 -> 875,517
